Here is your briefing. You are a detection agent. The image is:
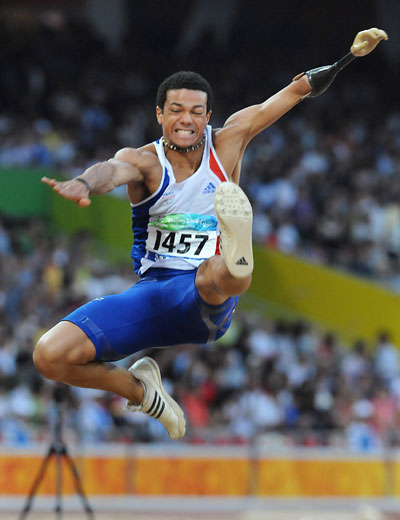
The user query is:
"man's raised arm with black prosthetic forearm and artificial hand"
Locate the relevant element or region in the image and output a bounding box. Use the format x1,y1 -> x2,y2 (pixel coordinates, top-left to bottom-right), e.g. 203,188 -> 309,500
215,28 -> 388,177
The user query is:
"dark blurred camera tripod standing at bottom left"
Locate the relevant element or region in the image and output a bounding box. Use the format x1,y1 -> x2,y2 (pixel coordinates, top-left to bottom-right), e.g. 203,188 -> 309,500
19,384 -> 94,520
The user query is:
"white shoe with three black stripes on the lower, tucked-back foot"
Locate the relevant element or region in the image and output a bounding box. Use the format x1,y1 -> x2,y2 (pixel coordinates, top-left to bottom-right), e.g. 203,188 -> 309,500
126,357 -> 186,439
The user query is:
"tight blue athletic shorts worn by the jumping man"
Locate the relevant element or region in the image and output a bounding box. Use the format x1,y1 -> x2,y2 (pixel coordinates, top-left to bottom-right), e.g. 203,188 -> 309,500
63,269 -> 238,361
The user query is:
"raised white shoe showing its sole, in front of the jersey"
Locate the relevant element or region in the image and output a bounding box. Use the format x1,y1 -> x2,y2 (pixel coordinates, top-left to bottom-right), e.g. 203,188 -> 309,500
214,182 -> 254,278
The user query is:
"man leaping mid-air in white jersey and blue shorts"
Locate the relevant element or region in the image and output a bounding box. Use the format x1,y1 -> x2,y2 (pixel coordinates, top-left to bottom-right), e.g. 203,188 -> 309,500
34,28 -> 387,439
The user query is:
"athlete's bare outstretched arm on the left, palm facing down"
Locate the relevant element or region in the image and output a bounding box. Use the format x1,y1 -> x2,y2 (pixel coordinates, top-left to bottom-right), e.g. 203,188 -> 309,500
42,148 -> 156,207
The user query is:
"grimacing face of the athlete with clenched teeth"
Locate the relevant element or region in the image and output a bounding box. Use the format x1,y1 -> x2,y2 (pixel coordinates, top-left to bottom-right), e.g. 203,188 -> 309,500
157,88 -> 211,148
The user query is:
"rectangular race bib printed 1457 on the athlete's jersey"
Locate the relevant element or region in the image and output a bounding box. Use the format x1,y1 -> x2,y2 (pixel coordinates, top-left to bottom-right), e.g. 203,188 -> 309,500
146,213 -> 217,259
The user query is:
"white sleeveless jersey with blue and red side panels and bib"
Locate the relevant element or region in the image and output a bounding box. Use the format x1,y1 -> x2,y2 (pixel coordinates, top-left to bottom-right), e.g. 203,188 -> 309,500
131,125 -> 229,275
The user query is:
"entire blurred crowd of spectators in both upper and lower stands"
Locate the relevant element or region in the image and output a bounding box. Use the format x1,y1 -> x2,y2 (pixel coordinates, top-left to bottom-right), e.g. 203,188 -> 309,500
0,7 -> 400,451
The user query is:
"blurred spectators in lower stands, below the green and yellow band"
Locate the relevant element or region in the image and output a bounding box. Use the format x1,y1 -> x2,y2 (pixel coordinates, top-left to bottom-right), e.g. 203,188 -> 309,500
0,221 -> 400,452
